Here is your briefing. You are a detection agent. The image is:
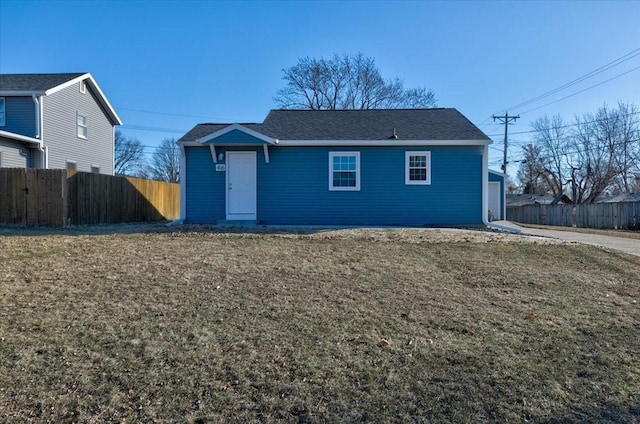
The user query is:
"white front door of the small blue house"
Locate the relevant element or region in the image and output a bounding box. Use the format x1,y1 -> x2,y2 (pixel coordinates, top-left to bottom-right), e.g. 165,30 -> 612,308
227,152 -> 257,220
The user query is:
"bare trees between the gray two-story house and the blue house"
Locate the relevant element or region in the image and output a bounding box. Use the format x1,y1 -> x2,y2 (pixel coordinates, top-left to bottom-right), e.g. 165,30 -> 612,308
114,131 -> 180,183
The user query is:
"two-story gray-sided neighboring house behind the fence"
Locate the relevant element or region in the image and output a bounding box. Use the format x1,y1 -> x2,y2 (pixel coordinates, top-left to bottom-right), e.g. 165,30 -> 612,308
0,73 -> 122,175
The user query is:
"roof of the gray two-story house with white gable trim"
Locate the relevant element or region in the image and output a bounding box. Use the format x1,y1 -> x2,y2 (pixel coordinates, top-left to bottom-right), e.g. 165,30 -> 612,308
0,72 -> 122,125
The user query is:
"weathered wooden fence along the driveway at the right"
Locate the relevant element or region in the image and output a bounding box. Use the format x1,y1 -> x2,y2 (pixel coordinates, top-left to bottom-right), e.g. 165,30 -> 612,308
507,202 -> 640,230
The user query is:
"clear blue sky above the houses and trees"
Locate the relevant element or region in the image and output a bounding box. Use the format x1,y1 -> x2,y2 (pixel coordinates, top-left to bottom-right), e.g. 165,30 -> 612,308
0,0 -> 640,174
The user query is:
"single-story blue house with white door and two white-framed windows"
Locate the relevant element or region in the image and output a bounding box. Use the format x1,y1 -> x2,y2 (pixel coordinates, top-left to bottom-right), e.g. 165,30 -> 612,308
178,109 -> 491,226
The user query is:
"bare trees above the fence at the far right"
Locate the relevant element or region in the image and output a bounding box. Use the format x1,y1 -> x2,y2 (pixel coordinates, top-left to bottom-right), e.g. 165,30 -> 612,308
516,102 -> 640,203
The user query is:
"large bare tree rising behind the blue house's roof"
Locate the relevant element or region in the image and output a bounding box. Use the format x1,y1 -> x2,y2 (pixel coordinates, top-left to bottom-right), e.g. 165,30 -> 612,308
275,53 -> 436,110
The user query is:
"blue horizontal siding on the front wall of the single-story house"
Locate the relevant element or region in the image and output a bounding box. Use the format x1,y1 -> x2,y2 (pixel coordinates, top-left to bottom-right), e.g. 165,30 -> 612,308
186,147 -> 483,226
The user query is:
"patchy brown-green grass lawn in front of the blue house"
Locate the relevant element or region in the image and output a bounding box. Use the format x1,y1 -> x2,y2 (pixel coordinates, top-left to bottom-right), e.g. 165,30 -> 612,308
0,228 -> 640,423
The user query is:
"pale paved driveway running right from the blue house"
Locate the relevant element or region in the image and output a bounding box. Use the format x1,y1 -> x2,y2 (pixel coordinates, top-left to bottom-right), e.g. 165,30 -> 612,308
496,221 -> 640,256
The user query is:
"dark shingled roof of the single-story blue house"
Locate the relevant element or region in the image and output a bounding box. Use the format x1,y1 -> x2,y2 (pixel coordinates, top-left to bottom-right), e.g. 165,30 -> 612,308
179,108 -> 489,141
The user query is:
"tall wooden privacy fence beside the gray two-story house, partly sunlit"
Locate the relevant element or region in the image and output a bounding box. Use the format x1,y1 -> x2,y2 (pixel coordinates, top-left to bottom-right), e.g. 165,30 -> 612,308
0,168 -> 180,227
